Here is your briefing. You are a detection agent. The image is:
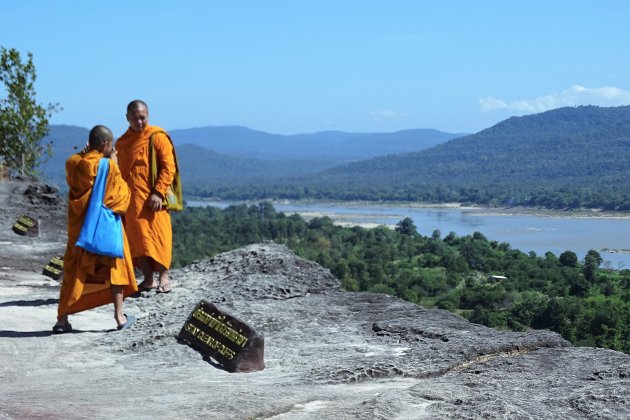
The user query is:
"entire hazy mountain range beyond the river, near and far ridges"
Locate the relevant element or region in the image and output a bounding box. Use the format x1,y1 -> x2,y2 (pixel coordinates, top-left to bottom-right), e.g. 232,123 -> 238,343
38,106 -> 630,211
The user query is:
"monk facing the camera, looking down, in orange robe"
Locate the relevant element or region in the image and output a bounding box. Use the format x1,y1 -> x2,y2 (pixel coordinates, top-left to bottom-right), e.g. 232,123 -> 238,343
116,100 -> 176,293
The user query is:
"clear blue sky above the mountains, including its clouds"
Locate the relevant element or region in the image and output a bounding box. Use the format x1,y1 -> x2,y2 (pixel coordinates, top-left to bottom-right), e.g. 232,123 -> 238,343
0,0 -> 630,135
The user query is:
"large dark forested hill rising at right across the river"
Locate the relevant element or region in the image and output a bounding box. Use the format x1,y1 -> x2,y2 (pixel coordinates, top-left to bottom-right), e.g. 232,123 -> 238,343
278,106 -> 630,210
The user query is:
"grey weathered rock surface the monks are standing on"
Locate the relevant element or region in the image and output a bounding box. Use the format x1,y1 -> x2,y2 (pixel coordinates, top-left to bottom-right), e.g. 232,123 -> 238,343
0,182 -> 630,419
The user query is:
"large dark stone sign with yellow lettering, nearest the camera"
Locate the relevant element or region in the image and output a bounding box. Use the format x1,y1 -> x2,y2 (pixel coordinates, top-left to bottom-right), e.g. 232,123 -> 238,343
177,300 -> 265,372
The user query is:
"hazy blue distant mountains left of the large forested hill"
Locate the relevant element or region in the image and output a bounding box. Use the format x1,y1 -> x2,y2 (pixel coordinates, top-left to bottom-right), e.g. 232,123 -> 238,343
41,125 -> 464,192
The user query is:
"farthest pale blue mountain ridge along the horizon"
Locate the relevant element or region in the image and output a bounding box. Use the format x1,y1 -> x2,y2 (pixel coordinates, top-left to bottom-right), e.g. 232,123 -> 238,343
170,126 -> 464,164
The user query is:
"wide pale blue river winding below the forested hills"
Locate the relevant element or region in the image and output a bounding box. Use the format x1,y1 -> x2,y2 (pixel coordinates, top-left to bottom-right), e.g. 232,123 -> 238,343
188,201 -> 630,269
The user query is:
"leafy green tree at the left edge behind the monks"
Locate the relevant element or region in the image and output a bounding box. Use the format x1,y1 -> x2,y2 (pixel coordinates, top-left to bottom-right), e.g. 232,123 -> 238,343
0,47 -> 58,175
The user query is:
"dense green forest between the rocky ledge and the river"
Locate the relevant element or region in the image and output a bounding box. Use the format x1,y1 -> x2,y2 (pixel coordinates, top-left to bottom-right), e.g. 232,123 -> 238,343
173,202 -> 630,353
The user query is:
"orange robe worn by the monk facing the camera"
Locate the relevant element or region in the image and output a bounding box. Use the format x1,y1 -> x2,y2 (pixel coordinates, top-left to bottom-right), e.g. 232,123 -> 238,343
116,126 -> 176,271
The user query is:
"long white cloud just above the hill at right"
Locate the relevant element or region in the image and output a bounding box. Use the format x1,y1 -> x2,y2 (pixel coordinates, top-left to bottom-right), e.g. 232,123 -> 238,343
479,85 -> 630,114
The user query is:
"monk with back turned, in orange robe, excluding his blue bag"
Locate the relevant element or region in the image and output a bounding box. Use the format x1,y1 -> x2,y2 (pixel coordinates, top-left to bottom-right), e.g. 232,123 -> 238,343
53,125 -> 138,334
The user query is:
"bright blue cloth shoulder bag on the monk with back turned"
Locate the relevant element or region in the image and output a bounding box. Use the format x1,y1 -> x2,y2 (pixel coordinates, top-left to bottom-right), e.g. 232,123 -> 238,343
75,158 -> 123,258
